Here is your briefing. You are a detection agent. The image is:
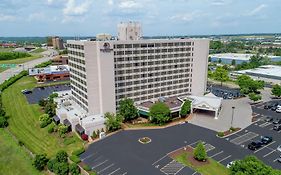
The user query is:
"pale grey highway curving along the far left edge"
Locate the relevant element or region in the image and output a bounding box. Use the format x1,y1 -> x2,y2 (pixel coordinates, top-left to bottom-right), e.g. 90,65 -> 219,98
0,49 -> 58,84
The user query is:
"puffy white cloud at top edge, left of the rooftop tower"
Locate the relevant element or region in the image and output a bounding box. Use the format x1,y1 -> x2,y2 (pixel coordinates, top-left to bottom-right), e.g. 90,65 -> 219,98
63,0 -> 91,16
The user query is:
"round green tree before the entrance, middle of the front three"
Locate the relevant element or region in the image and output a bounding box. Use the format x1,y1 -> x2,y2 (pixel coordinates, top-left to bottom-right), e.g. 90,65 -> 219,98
149,102 -> 171,125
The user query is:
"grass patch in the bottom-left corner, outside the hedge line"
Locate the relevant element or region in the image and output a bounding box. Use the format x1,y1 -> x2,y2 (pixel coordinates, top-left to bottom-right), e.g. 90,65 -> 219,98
0,129 -> 40,175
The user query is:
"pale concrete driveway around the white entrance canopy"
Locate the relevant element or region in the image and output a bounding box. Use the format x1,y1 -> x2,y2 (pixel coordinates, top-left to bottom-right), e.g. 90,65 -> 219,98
190,98 -> 252,131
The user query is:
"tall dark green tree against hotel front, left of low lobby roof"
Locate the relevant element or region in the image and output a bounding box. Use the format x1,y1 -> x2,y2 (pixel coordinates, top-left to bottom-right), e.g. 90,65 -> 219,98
119,98 -> 138,121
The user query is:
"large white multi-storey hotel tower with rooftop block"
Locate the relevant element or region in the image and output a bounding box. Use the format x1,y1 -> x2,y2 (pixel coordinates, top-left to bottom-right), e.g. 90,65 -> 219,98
67,22 -> 209,115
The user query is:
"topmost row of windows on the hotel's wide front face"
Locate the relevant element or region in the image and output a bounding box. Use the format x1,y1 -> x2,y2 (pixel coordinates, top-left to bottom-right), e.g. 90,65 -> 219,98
114,42 -> 194,49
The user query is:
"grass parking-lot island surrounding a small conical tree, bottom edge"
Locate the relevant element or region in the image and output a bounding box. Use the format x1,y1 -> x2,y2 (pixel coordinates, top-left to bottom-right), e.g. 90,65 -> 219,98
175,152 -> 230,175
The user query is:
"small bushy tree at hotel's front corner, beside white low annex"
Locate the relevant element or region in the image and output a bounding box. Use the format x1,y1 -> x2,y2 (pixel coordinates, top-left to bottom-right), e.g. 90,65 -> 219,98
104,112 -> 122,132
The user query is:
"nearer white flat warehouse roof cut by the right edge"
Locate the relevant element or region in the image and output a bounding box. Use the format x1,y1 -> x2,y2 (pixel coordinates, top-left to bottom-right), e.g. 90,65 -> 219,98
235,65 -> 281,77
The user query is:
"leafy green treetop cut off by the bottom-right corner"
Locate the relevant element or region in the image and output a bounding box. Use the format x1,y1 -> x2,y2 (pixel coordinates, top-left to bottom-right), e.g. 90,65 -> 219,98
230,156 -> 281,175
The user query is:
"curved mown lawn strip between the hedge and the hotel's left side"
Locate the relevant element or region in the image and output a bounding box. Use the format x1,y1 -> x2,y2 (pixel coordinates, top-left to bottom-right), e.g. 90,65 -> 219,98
2,77 -> 83,156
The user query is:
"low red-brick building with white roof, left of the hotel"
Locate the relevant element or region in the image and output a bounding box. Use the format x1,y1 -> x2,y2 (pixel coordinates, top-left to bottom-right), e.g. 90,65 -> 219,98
29,65 -> 69,82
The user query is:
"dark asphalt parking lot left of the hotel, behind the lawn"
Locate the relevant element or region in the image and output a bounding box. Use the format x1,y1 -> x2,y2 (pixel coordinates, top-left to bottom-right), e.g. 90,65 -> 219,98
25,85 -> 70,104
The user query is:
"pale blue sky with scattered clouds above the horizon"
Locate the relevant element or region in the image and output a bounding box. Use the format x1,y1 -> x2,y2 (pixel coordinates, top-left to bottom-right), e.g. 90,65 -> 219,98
0,0 -> 281,37
